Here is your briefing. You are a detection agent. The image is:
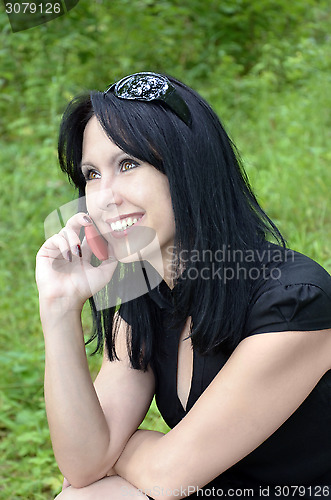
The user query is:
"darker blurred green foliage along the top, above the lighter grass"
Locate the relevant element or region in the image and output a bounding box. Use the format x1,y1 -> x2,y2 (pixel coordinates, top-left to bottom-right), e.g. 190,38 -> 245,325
0,0 -> 331,137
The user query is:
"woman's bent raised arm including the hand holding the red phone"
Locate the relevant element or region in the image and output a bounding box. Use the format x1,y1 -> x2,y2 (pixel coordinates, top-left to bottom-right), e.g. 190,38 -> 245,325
36,214 -> 154,487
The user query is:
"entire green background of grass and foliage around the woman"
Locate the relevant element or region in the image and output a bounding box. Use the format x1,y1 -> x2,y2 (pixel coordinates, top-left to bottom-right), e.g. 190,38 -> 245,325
0,0 -> 331,500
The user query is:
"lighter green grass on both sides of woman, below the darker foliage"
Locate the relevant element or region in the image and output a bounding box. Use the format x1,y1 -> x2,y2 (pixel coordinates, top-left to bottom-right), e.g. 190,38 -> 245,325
0,63 -> 331,500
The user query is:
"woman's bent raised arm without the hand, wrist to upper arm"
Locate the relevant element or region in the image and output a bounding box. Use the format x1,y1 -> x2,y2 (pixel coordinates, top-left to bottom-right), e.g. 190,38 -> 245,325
44,304 -> 154,487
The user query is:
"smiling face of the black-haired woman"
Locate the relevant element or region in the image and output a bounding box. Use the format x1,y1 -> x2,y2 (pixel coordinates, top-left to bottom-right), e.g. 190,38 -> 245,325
82,116 -> 175,266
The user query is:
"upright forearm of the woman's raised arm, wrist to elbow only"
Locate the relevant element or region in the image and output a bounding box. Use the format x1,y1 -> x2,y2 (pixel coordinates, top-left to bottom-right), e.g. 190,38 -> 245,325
41,298 -> 111,486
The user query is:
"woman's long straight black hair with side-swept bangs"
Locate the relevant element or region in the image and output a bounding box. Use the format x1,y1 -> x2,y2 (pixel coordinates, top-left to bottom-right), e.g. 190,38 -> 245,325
59,77 -> 285,369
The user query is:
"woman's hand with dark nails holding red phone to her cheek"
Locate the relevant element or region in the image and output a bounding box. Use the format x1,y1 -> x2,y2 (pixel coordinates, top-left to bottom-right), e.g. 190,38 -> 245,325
36,212 -> 118,309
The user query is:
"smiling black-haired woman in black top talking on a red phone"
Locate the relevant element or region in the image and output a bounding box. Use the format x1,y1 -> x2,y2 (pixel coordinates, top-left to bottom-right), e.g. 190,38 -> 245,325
36,73 -> 331,499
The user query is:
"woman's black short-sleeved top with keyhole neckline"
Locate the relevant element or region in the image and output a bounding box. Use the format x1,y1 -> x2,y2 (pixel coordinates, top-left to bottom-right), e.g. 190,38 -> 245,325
120,245 -> 331,498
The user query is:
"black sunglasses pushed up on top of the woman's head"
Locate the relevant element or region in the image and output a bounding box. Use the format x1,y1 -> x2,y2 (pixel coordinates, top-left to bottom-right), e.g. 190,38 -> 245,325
103,72 -> 192,126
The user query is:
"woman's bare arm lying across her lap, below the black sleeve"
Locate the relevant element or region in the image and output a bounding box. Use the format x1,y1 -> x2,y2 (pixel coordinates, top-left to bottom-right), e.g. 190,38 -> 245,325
115,330 -> 331,498
